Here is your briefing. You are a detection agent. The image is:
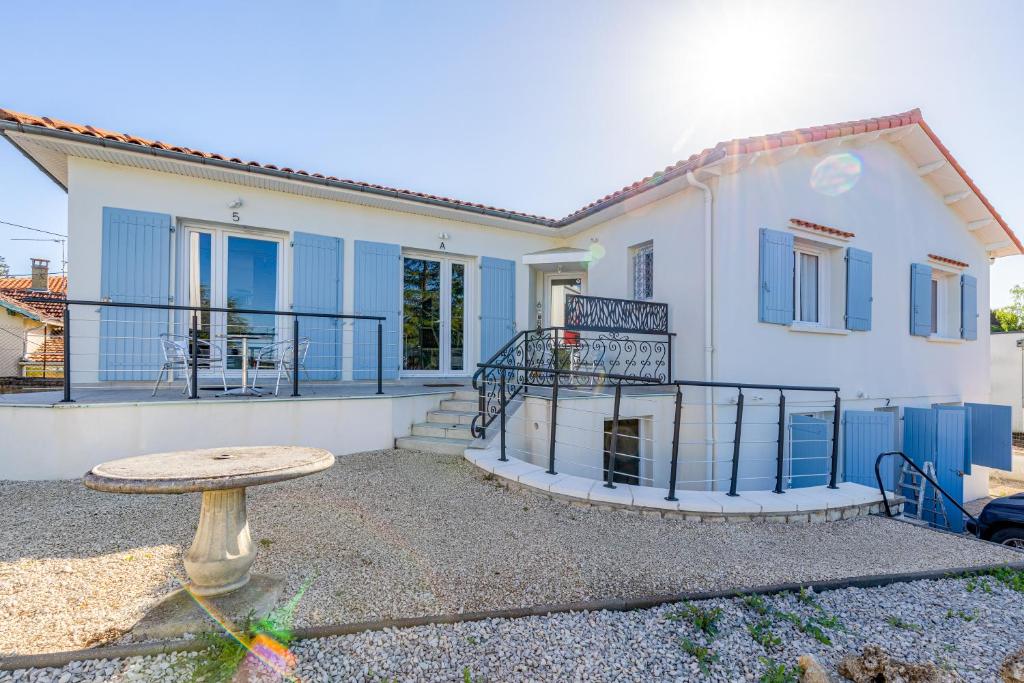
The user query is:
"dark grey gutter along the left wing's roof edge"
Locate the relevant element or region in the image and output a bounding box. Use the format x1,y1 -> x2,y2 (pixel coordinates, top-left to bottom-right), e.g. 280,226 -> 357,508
0,120 -> 555,228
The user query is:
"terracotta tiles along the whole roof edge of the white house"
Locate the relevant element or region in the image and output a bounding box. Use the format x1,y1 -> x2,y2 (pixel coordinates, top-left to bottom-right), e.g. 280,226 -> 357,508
0,109 -> 1024,253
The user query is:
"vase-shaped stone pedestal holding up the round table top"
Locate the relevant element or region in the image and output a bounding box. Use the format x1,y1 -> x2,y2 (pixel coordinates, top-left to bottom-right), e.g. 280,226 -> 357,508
184,488 -> 256,596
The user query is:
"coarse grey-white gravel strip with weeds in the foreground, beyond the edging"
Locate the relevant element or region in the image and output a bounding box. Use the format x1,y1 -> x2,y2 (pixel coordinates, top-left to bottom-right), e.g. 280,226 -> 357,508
0,578 -> 1024,683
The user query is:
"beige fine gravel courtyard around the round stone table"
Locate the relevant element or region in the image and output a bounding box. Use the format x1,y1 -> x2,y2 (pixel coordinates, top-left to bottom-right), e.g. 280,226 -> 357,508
0,451 -> 1020,655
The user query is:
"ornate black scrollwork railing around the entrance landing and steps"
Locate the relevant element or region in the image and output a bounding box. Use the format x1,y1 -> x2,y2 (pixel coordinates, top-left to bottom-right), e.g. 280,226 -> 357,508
472,327 -> 675,436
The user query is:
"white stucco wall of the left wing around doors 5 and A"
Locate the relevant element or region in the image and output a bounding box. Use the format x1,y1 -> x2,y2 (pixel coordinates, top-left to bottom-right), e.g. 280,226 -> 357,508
68,157 -> 557,378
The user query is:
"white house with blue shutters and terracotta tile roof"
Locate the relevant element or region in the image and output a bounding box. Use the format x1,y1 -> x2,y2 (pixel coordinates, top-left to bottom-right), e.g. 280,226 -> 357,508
0,105 -> 1024,511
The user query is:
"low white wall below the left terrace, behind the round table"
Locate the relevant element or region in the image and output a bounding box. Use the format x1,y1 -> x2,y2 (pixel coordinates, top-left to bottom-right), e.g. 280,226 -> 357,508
0,394 -> 442,479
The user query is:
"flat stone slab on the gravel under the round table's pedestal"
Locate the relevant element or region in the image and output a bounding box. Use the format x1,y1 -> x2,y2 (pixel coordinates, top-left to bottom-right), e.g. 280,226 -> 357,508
131,574 -> 285,640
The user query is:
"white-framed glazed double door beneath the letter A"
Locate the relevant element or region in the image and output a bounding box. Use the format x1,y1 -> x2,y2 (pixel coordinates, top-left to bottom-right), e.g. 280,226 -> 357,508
401,253 -> 470,375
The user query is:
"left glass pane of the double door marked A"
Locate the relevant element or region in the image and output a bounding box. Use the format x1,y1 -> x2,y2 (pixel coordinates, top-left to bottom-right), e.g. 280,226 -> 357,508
402,258 -> 441,370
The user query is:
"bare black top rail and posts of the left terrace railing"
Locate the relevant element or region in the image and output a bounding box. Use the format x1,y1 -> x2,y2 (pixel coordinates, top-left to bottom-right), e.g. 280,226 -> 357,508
24,297 -> 387,403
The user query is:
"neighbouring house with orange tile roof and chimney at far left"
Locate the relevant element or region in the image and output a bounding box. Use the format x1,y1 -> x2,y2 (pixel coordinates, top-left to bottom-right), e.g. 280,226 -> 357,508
0,259 -> 68,377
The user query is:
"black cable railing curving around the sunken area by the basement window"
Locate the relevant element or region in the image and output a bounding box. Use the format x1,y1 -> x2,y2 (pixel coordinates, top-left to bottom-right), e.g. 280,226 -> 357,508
473,350 -> 842,493
